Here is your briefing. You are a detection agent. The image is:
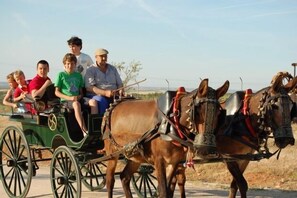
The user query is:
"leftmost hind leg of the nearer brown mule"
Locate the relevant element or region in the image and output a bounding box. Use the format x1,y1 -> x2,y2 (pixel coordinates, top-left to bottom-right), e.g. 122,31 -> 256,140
106,158 -> 118,198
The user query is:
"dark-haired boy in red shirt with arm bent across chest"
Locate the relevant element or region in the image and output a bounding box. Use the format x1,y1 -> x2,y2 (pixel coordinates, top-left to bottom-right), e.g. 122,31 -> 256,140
29,60 -> 52,98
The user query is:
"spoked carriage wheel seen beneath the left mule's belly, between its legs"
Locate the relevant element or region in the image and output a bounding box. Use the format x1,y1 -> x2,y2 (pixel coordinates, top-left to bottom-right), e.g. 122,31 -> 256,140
132,165 -> 158,198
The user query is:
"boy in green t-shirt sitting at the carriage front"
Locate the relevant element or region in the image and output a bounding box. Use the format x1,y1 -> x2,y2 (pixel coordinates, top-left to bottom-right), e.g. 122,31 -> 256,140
55,53 -> 98,136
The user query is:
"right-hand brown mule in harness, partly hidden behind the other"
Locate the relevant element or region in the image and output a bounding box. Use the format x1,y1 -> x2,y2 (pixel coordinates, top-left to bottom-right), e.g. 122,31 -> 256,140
171,72 -> 297,198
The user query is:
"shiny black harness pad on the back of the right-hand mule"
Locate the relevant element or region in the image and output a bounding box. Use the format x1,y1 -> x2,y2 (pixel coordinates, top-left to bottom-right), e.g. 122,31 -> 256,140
225,91 -> 245,116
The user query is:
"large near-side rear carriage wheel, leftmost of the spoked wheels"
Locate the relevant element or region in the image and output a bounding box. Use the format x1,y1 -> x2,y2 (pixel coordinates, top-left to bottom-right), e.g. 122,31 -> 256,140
0,126 -> 33,198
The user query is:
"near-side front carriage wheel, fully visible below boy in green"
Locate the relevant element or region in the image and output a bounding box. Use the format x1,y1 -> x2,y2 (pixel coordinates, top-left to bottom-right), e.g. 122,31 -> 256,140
50,146 -> 81,198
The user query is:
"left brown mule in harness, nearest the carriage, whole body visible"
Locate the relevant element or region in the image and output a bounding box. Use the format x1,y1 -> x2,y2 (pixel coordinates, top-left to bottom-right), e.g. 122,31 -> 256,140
102,79 -> 229,197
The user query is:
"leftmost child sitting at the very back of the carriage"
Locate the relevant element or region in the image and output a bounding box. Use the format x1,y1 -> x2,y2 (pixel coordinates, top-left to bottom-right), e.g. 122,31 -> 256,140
3,73 -> 18,109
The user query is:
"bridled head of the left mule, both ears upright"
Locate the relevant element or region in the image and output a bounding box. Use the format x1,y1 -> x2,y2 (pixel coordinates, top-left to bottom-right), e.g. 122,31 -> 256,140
179,79 -> 229,156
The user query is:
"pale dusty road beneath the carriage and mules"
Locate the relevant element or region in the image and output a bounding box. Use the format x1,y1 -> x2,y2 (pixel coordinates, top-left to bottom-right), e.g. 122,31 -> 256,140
0,166 -> 297,198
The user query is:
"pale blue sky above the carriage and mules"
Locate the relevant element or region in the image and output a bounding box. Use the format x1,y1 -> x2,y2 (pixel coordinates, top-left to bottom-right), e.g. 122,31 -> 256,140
0,0 -> 297,90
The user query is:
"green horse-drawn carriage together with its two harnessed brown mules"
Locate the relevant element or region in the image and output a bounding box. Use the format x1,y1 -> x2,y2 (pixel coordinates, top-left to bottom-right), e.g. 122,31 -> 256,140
0,72 -> 297,197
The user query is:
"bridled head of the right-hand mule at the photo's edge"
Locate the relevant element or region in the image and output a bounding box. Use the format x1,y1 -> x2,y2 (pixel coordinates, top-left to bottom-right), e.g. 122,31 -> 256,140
258,73 -> 297,148
